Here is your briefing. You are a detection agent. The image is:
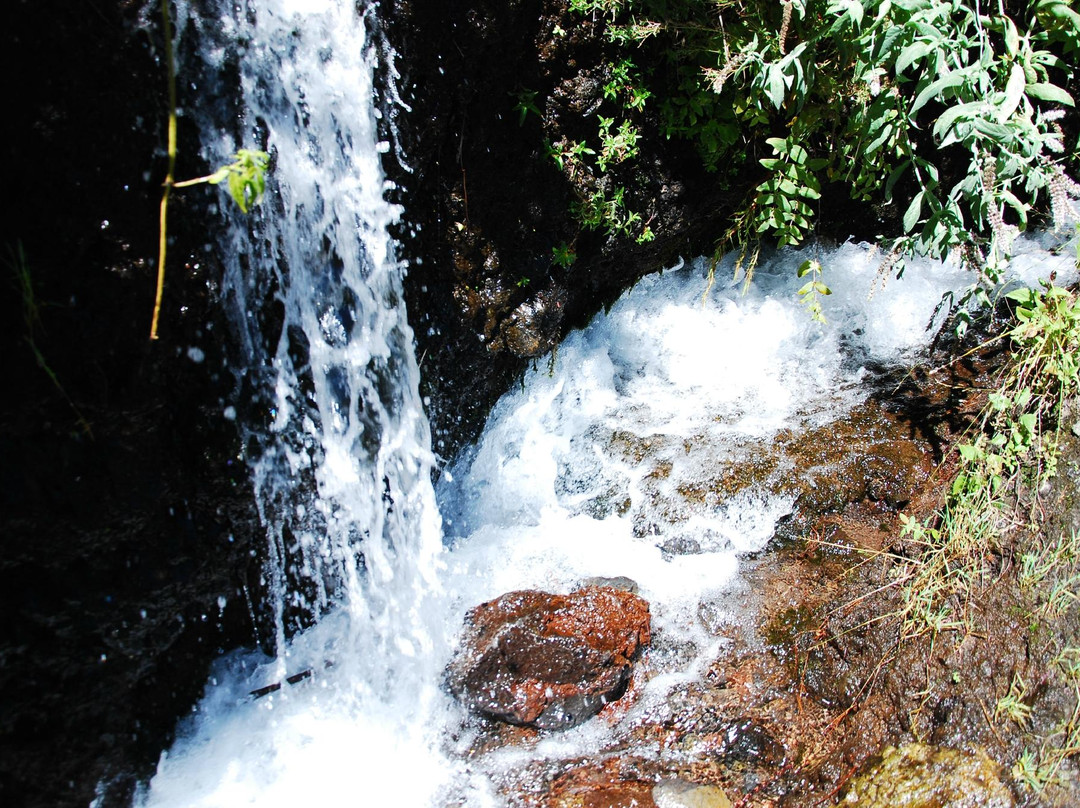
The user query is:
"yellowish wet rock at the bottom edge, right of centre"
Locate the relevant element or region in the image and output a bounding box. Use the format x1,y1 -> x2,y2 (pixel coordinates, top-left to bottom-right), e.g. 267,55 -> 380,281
842,743 -> 1014,808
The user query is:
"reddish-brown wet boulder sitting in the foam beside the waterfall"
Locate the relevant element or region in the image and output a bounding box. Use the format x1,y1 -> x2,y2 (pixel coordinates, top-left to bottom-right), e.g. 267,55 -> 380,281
447,587 -> 650,729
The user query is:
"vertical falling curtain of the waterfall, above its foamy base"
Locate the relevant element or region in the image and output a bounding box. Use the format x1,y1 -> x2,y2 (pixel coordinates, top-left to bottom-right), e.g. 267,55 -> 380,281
177,0 -> 440,656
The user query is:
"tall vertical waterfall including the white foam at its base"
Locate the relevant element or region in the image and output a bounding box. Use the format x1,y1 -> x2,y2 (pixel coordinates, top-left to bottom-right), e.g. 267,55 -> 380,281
141,0 -> 455,806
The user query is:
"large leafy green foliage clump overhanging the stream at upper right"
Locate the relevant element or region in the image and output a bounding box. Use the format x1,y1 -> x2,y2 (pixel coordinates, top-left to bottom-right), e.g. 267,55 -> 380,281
570,0 -> 1080,295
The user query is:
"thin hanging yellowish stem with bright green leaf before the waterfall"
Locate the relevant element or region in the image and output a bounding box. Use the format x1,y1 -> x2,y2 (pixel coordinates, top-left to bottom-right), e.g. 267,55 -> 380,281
150,0 -> 270,339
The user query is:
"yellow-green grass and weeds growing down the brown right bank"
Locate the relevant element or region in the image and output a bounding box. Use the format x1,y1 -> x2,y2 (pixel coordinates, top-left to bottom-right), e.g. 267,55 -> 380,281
902,285 -> 1080,634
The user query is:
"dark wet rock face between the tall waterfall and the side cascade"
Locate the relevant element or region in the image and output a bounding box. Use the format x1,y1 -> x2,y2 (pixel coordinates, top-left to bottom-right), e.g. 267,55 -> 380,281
383,0 -> 741,457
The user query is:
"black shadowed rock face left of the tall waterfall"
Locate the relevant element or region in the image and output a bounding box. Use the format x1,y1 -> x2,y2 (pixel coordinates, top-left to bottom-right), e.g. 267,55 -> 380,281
0,0 -> 261,807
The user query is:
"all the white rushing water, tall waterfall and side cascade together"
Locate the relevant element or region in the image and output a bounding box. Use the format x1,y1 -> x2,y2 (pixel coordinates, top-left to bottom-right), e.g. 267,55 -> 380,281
132,0 -> 1068,807
